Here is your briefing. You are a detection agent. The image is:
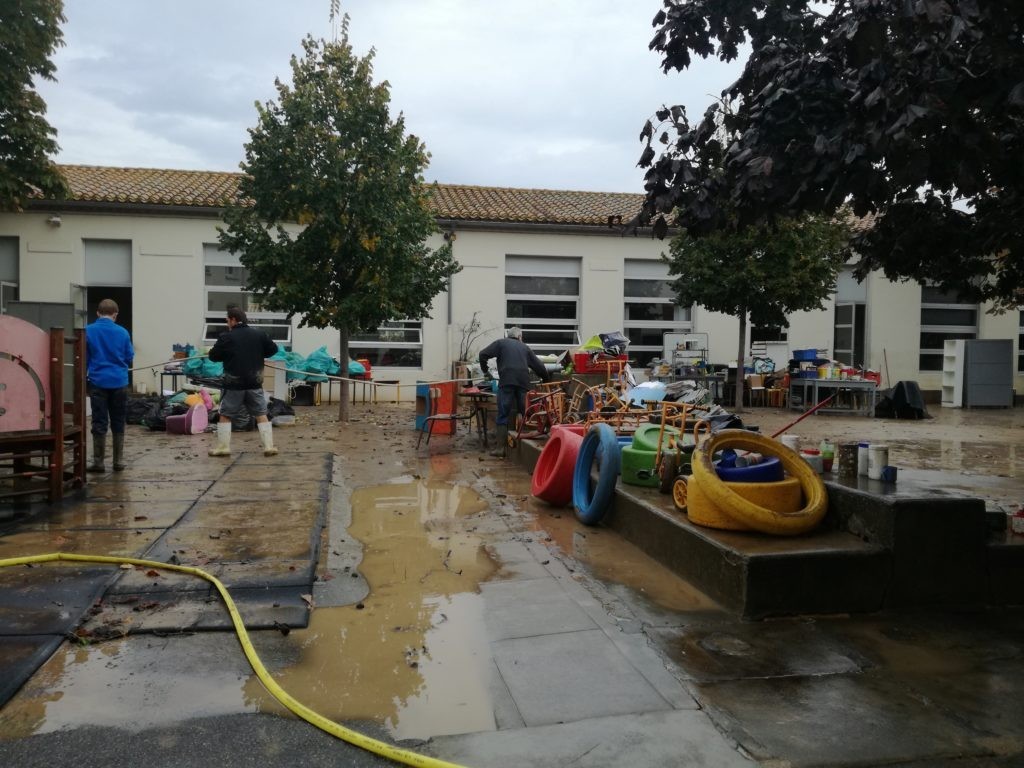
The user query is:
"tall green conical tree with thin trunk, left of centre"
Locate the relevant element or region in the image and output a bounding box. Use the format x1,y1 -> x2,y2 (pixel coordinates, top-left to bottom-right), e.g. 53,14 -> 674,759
220,17 -> 460,421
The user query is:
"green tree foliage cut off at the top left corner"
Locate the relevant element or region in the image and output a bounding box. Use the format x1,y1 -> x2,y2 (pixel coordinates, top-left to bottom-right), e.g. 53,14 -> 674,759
0,0 -> 68,211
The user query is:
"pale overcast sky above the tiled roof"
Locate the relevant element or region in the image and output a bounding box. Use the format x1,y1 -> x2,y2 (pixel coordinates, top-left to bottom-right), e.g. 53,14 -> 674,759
40,0 -> 739,191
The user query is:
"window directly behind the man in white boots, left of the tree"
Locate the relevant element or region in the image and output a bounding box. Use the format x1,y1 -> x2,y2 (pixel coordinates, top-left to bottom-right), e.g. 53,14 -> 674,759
203,243 -> 292,344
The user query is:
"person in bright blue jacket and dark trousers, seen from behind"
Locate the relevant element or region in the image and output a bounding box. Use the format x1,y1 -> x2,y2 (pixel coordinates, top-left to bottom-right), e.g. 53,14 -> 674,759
85,299 -> 135,472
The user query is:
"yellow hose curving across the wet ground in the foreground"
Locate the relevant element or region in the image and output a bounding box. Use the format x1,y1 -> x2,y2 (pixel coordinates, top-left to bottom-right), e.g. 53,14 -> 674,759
0,552 -> 462,768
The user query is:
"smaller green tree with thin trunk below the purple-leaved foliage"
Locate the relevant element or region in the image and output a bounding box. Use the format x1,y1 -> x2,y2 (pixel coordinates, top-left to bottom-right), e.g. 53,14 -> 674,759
666,216 -> 850,411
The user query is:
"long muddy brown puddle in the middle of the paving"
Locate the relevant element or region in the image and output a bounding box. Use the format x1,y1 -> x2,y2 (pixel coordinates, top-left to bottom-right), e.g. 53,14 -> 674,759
245,478 -> 498,739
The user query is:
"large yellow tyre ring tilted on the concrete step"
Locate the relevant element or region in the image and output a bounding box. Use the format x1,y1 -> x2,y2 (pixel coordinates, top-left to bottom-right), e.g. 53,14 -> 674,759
693,429 -> 828,536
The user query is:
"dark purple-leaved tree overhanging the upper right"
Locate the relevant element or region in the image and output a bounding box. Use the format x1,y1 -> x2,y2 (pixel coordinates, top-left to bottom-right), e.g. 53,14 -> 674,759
640,0 -> 1024,309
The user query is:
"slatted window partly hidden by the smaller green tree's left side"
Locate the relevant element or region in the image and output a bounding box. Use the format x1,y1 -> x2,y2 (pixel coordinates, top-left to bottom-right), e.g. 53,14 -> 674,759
623,259 -> 693,368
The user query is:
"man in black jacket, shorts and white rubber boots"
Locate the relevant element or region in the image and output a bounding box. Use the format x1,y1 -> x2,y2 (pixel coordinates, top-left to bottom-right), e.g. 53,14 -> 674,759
208,306 -> 278,456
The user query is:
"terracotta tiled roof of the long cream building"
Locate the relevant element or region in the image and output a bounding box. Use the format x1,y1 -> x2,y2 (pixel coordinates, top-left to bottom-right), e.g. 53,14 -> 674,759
49,165 -> 643,226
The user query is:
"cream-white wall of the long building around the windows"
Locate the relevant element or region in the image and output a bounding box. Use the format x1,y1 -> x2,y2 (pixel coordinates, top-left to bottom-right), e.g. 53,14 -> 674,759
0,213 -> 1024,399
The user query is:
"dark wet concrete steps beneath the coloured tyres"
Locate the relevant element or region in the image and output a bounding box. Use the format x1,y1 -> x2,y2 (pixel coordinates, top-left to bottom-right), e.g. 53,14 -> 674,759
513,440 -> 1024,618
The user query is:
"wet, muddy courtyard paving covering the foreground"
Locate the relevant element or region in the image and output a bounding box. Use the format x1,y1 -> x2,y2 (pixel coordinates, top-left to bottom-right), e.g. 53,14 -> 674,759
0,406 -> 1024,767
